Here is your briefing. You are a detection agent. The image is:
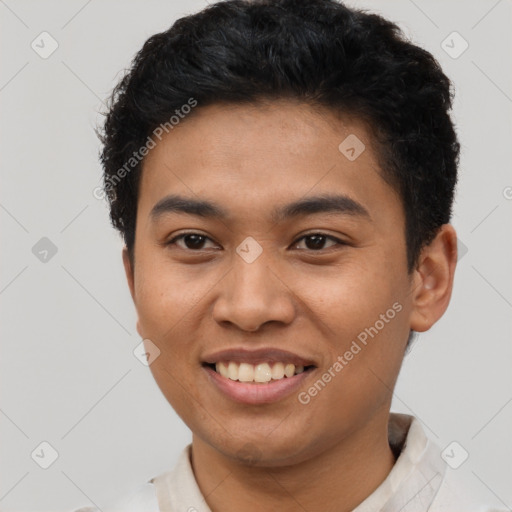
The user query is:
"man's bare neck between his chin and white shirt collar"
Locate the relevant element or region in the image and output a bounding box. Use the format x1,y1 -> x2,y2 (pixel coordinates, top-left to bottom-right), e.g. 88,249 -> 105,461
192,411 -> 395,512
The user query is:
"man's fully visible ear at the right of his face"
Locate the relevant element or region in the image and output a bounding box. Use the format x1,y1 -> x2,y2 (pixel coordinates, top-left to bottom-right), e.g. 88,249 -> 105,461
410,224 -> 457,332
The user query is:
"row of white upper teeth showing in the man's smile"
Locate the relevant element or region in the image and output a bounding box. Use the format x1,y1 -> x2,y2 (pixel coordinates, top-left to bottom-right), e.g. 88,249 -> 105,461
215,361 -> 304,382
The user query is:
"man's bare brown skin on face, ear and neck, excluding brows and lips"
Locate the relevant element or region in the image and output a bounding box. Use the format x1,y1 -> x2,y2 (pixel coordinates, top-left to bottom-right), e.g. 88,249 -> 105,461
123,100 -> 457,512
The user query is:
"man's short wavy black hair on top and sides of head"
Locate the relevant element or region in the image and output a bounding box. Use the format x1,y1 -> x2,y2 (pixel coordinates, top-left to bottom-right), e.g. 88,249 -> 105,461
99,0 -> 460,273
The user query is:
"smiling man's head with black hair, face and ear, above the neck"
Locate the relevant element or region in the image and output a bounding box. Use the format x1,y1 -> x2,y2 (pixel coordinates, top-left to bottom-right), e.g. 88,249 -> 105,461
98,0 -> 459,465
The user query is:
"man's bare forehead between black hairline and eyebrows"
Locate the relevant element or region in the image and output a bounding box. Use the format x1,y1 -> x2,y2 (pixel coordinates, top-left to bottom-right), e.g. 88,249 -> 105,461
139,101 -> 397,225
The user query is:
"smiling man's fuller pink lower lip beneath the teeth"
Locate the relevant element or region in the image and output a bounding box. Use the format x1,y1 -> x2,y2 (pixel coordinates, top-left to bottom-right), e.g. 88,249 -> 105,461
203,366 -> 314,405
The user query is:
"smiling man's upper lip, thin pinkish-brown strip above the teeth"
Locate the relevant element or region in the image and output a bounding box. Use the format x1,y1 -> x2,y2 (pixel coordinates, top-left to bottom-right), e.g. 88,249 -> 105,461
203,348 -> 316,366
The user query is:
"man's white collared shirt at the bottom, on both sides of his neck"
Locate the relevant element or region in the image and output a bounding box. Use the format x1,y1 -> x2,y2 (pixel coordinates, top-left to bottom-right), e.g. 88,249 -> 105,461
74,413 -> 505,512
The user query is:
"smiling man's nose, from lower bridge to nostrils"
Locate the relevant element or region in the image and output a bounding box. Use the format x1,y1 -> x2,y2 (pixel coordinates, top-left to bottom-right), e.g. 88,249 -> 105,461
213,256 -> 295,332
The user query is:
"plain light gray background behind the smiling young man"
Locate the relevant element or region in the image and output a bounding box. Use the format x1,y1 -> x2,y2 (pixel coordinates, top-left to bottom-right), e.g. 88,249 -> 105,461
0,0 -> 512,512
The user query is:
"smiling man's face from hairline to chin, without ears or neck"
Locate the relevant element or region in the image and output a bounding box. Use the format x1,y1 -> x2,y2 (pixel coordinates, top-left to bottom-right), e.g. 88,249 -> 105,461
124,101 -> 426,466
